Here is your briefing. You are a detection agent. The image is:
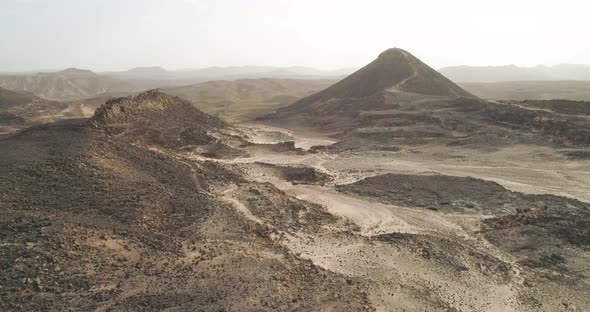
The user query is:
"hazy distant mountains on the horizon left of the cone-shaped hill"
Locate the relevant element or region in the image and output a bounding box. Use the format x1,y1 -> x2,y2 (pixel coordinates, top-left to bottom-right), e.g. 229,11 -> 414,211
0,66 -> 354,101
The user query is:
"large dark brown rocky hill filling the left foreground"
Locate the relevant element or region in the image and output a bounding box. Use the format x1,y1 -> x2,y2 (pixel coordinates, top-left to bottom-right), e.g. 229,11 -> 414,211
0,91 -> 370,311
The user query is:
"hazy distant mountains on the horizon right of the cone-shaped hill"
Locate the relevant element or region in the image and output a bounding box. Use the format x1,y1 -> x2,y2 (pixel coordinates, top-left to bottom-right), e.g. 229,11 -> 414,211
439,64 -> 590,82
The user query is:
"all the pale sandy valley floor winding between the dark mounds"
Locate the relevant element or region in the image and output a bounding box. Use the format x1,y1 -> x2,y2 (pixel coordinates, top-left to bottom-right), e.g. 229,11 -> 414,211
212,124 -> 590,311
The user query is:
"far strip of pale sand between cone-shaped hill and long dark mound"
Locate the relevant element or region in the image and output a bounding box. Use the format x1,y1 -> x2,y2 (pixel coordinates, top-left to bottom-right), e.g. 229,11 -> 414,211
236,124 -> 590,202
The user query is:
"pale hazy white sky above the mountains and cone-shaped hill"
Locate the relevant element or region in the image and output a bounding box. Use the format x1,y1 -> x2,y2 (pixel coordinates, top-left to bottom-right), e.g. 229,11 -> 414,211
0,0 -> 590,71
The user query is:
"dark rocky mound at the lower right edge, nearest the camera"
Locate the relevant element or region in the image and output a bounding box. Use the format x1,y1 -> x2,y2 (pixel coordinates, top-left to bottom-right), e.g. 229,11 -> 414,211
483,196 -> 590,311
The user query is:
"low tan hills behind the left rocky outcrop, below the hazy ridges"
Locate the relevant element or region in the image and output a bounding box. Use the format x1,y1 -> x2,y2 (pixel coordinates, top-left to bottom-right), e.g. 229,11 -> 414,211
0,77 -> 333,133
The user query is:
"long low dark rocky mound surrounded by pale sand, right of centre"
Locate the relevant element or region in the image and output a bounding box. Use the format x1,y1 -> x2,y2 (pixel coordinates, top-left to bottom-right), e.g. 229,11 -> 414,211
337,174 -> 590,214
